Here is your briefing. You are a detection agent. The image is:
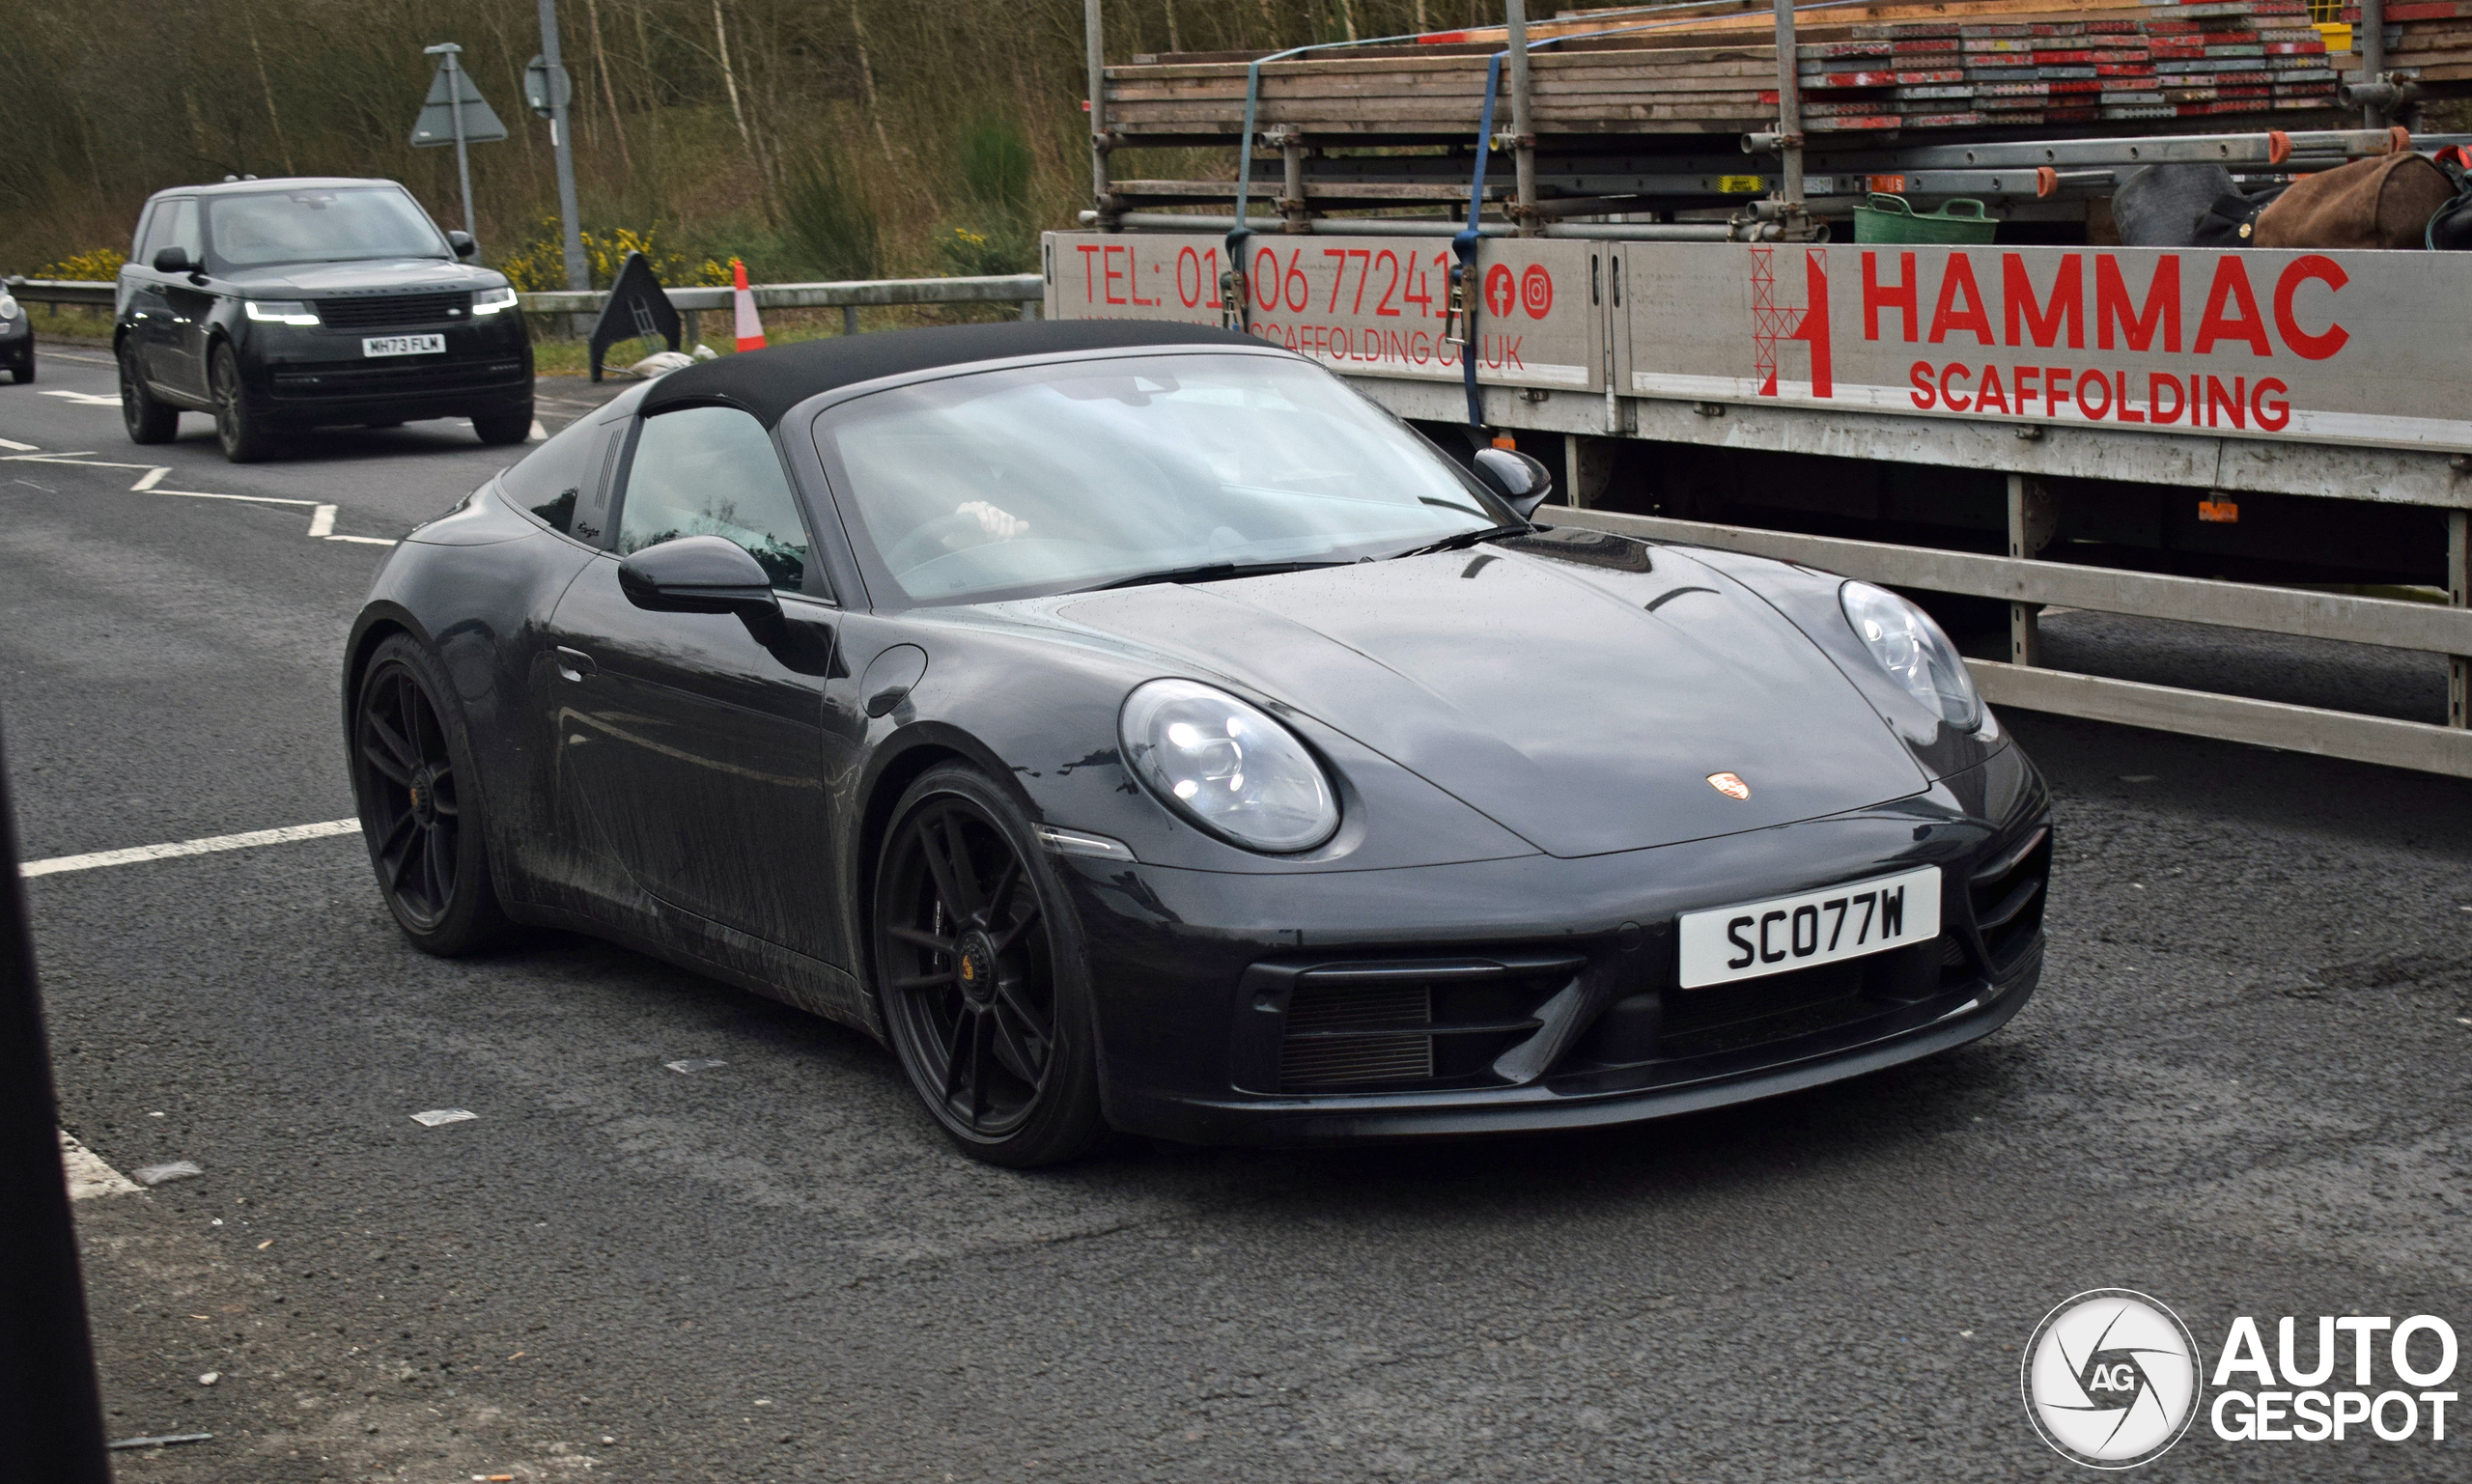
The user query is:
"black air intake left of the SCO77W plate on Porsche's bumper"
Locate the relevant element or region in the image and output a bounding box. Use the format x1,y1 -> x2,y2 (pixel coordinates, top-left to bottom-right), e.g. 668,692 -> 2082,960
1239,952 -> 1587,1093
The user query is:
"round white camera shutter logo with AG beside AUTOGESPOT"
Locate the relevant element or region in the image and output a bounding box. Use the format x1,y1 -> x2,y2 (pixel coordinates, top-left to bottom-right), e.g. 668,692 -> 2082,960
2020,1289 -> 2200,1470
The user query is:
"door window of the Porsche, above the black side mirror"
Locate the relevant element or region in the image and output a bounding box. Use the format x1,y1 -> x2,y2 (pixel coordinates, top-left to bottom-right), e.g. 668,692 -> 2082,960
618,408 -> 808,591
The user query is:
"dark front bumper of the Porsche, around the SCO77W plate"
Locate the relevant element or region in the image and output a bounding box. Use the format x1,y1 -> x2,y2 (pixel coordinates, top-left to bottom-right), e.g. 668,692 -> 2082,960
1068,747 -> 2052,1145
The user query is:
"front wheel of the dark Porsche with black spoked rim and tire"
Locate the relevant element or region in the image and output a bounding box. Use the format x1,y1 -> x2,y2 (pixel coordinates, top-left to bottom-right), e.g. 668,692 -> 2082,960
870,765 -> 1110,1170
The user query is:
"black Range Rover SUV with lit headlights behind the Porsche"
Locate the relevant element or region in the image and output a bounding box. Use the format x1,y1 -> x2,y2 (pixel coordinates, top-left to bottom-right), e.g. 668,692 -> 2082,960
114,178 -> 531,462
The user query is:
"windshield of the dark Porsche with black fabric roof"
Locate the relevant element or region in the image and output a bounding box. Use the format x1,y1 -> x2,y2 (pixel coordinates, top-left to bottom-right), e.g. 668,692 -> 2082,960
816,353 -> 1518,603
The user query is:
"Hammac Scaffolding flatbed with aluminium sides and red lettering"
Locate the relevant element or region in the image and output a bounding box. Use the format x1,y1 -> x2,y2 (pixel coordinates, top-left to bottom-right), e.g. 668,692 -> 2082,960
1041,0 -> 2472,776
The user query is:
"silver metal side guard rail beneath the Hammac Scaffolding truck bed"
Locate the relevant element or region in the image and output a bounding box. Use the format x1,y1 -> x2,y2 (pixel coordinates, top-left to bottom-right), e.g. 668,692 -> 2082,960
1548,504 -> 2472,776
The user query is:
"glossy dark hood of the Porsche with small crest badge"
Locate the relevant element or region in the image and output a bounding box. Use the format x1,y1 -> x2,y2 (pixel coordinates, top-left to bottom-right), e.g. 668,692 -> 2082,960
1055,539 -> 1928,855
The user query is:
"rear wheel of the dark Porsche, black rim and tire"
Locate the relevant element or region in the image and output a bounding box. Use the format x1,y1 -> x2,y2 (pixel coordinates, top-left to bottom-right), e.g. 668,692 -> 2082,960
351,633 -> 509,957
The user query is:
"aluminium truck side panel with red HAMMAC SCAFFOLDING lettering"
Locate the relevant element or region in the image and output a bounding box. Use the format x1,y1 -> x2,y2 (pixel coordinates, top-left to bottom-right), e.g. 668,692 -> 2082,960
1616,242 -> 2472,457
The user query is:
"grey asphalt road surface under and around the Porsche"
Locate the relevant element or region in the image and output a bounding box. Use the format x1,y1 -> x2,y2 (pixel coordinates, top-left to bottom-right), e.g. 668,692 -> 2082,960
0,349 -> 2472,1484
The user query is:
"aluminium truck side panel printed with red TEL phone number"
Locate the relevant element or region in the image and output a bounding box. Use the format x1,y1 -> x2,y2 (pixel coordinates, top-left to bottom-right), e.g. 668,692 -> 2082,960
1043,233 -> 1607,393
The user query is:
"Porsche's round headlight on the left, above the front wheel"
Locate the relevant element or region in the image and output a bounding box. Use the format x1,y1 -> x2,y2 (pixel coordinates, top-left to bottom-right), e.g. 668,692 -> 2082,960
1117,680 -> 1340,851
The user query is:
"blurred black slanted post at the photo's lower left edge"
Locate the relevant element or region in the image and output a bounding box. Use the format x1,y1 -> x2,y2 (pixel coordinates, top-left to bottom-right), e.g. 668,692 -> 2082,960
0,712 -> 111,1484
